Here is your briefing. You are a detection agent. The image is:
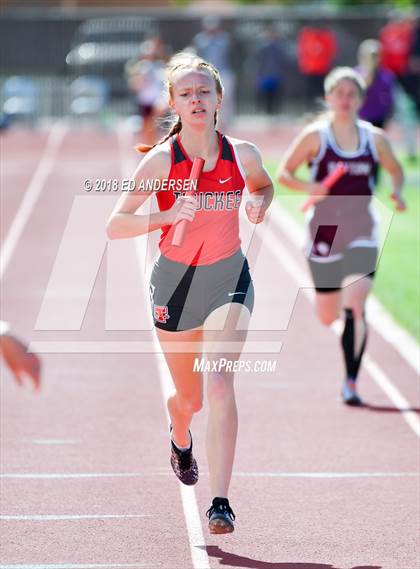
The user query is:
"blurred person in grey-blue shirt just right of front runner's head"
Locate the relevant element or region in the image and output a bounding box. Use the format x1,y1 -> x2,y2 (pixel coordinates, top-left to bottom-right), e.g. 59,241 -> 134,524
193,16 -> 236,130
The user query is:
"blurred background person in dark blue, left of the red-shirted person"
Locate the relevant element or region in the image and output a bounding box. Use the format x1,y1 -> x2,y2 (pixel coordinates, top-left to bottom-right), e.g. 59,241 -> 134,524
255,26 -> 285,115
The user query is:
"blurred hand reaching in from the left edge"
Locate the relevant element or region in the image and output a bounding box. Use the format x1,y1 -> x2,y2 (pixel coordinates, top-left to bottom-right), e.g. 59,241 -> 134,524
0,320 -> 41,390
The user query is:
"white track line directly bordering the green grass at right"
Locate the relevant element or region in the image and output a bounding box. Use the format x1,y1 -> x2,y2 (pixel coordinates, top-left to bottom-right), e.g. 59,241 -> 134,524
271,200 -> 420,373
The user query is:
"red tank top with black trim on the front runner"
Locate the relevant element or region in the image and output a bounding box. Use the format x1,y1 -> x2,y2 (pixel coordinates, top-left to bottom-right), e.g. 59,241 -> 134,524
157,132 -> 245,265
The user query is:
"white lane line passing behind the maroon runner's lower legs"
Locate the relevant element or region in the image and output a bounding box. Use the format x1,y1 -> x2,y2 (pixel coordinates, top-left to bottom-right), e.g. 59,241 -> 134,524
265,215 -> 420,436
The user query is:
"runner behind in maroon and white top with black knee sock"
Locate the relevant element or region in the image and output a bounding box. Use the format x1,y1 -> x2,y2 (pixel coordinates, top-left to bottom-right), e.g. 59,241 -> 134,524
278,67 -> 405,405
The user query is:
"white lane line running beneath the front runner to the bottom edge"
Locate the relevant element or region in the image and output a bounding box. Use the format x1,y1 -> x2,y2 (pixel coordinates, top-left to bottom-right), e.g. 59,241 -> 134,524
117,129 -> 210,569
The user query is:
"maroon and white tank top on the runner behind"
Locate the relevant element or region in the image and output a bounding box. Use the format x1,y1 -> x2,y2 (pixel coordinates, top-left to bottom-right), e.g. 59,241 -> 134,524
308,120 -> 378,261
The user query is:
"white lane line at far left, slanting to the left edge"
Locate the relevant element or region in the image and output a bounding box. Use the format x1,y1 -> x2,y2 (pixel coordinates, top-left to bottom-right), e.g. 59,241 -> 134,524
0,121 -> 68,279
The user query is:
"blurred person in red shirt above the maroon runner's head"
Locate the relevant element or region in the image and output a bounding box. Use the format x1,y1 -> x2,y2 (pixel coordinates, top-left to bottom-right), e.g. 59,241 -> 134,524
297,26 -> 337,102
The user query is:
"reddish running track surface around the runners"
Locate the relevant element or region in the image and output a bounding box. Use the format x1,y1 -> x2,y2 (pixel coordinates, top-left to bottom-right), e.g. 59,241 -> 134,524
0,124 -> 419,569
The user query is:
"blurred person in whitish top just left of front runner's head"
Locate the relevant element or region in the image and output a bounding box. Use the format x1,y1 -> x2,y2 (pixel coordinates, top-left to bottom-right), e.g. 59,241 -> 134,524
125,36 -> 169,144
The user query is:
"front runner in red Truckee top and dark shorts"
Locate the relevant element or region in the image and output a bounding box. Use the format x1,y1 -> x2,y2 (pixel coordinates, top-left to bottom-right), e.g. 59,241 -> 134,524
107,54 -> 273,533
